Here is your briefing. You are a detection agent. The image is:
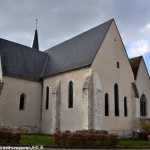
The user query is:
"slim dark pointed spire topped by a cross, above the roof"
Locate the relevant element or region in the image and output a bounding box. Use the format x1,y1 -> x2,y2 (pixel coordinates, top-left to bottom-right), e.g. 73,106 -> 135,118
32,19 -> 39,50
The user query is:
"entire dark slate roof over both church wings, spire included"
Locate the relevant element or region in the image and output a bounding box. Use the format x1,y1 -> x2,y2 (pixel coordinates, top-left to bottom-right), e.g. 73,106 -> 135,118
0,19 -> 113,81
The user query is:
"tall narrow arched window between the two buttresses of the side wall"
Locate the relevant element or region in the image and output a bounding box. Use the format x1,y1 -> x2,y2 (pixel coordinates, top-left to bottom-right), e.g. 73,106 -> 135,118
68,81 -> 73,108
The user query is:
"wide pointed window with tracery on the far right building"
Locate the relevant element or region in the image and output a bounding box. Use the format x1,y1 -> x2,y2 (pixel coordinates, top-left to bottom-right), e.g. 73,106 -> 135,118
140,94 -> 147,116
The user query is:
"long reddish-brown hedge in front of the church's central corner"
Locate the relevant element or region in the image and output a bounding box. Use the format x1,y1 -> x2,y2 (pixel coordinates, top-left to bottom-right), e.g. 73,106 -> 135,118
54,130 -> 119,147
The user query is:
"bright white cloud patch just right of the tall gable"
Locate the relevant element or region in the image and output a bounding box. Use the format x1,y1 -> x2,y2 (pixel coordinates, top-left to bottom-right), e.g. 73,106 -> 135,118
127,39 -> 150,57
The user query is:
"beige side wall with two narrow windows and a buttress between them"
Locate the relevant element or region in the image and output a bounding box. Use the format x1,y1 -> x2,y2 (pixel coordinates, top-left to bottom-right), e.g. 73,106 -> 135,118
42,68 -> 92,133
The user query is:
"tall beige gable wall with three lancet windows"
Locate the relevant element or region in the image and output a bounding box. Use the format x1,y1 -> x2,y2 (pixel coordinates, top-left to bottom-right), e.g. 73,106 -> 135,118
92,22 -> 134,133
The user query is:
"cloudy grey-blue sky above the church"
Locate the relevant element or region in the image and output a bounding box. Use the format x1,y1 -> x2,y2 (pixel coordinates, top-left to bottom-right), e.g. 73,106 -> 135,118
0,0 -> 150,73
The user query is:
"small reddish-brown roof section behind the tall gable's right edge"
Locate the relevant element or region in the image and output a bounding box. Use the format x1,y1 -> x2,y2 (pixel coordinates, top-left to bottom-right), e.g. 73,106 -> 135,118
130,56 -> 143,79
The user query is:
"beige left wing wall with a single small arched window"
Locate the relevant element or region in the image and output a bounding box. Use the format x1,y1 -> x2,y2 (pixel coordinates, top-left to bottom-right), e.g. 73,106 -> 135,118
0,76 -> 42,132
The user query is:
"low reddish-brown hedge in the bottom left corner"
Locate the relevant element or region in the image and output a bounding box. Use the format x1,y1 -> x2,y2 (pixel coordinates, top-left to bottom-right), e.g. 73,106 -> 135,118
0,128 -> 21,144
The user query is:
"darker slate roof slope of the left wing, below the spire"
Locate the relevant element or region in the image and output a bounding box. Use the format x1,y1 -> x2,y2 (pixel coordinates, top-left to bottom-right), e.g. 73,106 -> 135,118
0,38 -> 47,80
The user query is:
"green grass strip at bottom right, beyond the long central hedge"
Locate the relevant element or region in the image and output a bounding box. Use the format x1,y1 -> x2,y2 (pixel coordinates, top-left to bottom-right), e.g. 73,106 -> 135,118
119,139 -> 150,148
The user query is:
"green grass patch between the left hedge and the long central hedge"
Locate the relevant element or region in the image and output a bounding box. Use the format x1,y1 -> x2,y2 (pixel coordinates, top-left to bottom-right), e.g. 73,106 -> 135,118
20,134 -> 53,146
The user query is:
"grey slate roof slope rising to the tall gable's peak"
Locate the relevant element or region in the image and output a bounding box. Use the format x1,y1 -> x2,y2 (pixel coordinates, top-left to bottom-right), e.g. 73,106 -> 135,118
43,19 -> 113,76
